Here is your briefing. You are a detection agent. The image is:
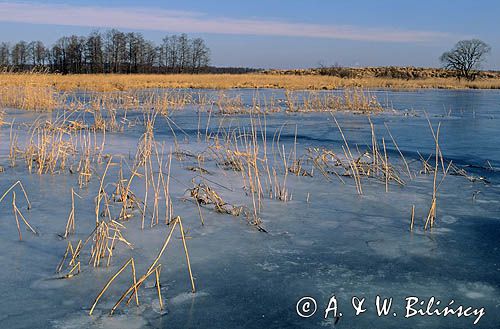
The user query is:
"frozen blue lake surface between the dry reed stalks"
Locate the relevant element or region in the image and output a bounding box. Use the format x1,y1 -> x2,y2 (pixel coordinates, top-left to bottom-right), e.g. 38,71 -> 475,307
0,90 -> 500,328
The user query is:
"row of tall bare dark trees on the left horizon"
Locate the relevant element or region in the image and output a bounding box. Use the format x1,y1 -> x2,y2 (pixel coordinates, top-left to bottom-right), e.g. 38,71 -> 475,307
0,29 -> 210,74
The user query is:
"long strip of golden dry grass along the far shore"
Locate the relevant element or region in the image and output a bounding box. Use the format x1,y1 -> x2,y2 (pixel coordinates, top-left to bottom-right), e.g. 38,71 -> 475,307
0,73 -> 500,91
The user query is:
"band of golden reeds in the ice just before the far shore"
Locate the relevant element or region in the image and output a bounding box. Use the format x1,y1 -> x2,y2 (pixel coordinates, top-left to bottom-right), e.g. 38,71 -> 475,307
0,79 -> 390,116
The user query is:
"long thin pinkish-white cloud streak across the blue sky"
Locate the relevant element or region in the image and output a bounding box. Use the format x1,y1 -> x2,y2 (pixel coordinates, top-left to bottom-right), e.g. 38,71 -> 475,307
0,2 -> 450,42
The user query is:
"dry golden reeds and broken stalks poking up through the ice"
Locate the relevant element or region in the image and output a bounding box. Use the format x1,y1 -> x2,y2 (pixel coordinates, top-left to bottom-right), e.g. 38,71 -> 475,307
0,84 -> 496,326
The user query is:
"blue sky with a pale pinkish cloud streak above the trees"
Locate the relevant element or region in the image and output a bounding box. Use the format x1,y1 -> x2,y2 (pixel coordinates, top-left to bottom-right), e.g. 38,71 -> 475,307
0,0 -> 500,70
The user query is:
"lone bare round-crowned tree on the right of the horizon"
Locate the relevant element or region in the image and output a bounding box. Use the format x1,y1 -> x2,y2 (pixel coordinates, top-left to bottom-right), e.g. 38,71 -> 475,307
440,39 -> 491,80
